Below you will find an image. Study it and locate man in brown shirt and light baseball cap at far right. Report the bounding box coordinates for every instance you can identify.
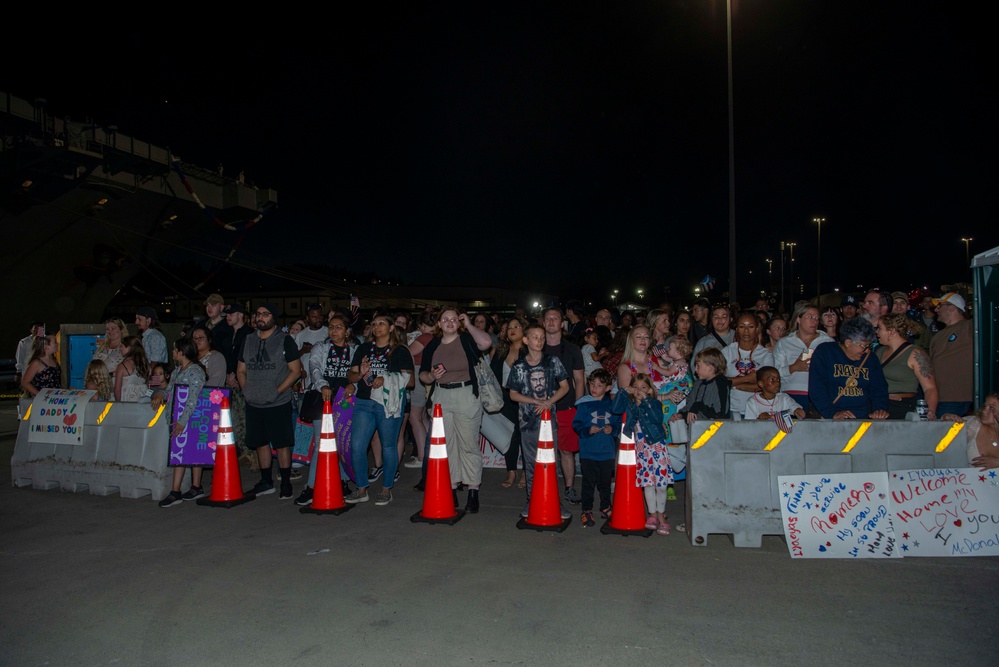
[930,292,975,417]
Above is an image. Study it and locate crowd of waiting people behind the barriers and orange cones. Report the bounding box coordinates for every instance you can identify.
[17,290,999,534]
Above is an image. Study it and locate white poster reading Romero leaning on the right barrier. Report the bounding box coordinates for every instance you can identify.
[777,472,902,558]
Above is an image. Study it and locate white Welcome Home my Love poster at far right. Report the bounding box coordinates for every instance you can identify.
[889,468,999,558]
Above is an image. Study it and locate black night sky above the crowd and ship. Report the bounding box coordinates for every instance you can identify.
[0,0,999,301]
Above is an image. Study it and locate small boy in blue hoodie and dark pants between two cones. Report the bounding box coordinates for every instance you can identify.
[572,368,621,528]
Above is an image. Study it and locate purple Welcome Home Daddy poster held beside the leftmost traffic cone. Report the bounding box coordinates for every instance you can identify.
[167,385,232,466]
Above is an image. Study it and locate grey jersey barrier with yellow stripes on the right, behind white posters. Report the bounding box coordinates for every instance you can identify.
[686,420,968,547]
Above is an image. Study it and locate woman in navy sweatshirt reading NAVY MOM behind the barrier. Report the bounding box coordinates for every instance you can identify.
[808,316,888,419]
